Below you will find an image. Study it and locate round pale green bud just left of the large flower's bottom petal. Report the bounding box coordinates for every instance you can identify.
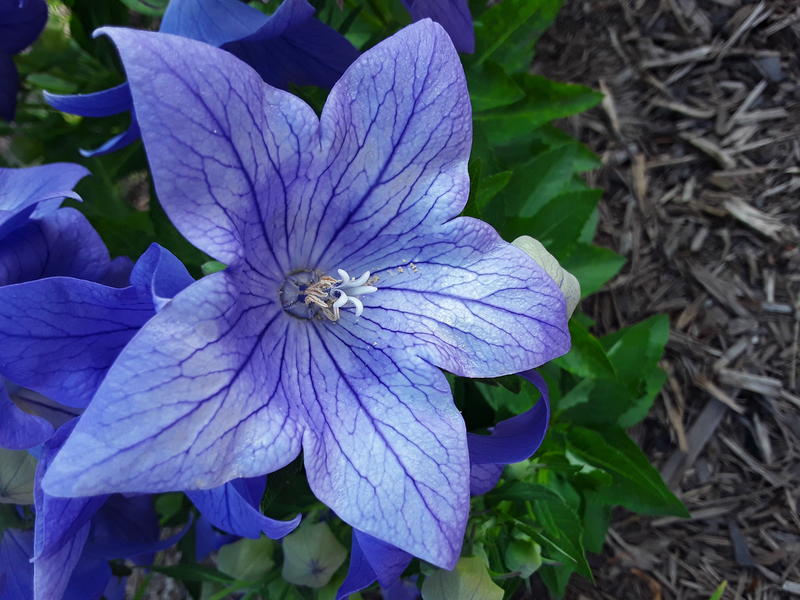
[282,523,347,588]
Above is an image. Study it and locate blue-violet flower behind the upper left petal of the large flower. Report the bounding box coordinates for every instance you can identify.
[45,0,358,156]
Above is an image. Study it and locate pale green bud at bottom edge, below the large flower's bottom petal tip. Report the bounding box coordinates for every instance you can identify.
[422,556,503,600]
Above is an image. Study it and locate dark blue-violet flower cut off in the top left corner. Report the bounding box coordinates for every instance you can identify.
[0,0,47,121]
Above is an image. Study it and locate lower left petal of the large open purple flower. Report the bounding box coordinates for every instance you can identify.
[44,269,300,496]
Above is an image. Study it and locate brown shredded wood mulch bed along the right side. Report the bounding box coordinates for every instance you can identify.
[535,0,800,600]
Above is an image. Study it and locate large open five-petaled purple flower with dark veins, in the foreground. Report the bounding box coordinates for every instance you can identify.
[44,20,569,567]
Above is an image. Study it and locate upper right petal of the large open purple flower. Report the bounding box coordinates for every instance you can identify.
[291,20,472,272]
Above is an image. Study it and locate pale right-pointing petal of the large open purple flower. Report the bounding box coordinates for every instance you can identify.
[353,217,569,377]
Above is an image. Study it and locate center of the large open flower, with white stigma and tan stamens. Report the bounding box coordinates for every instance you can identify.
[280,269,378,321]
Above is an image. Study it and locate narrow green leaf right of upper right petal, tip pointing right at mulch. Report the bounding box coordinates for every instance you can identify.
[473,75,602,144]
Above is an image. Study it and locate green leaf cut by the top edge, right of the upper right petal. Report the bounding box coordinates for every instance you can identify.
[475,0,561,72]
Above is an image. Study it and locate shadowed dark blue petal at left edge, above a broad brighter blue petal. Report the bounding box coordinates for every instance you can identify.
[0,208,110,286]
